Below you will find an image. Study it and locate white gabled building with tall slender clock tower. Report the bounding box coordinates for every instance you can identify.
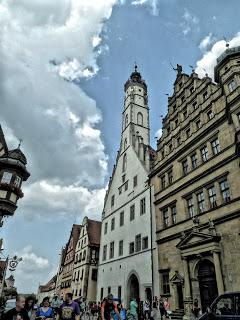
[97,66,159,305]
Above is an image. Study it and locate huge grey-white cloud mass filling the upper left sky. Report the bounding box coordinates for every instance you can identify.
[0,0,121,222]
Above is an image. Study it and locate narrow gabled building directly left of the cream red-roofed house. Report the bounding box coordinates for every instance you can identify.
[57,224,81,297]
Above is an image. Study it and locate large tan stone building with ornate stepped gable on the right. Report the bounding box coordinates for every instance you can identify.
[150,47,240,317]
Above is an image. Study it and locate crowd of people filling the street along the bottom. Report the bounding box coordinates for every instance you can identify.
[3,293,201,320]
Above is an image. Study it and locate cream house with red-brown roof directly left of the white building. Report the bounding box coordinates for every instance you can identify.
[72,217,101,301]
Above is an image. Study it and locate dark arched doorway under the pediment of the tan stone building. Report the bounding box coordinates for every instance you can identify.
[198,260,218,312]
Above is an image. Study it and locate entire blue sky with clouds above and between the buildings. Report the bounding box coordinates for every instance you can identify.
[0,0,240,293]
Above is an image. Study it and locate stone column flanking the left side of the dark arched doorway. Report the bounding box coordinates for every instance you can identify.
[182,257,192,320]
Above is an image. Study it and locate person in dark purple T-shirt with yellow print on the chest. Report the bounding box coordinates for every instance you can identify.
[56,292,80,320]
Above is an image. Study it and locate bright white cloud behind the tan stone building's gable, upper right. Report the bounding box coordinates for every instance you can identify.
[196,32,240,78]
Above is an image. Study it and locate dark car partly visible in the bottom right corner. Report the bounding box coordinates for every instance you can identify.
[199,291,240,320]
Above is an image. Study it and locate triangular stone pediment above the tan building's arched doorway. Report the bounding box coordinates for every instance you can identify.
[177,230,220,250]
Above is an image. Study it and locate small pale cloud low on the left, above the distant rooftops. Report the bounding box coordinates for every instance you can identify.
[14,245,57,293]
